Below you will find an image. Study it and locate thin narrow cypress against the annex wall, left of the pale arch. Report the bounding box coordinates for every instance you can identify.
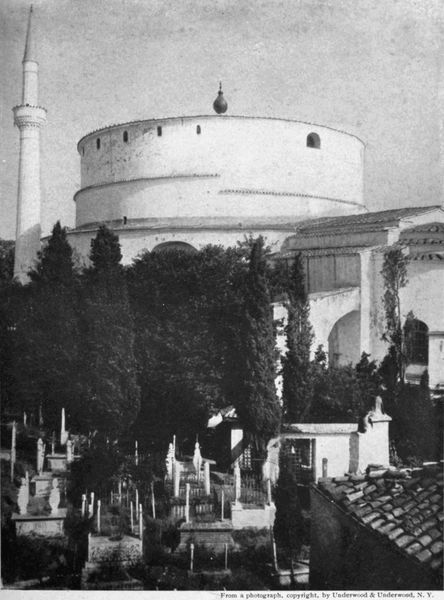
[282,254,313,421]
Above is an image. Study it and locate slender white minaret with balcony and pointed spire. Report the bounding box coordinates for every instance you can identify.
[12,5,46,283]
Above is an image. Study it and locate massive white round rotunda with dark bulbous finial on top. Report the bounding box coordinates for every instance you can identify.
[69,91,365,262]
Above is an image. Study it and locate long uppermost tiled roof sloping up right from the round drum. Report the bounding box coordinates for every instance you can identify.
[297,205,441,234]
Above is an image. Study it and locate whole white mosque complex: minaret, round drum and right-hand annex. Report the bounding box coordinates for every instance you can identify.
[14,11,444,393]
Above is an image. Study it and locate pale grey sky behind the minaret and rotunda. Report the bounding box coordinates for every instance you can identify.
[0,0,444,238]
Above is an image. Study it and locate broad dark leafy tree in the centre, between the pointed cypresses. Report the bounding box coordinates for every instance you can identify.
[128,246,245,449]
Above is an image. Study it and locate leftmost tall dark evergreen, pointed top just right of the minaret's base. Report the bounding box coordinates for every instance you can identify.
[10,222,80,429]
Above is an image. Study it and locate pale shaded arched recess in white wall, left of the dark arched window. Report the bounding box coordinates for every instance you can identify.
[328,310,361,367]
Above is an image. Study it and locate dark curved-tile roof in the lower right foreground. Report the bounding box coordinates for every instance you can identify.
[318,463,444,573]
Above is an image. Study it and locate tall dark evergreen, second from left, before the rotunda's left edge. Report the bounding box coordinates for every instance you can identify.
[81,226,140,438]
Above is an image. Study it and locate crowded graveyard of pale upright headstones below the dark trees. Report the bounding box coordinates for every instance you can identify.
[2,409,298,590]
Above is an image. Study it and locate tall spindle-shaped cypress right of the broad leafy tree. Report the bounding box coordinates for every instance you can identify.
[235,237,281,453]
